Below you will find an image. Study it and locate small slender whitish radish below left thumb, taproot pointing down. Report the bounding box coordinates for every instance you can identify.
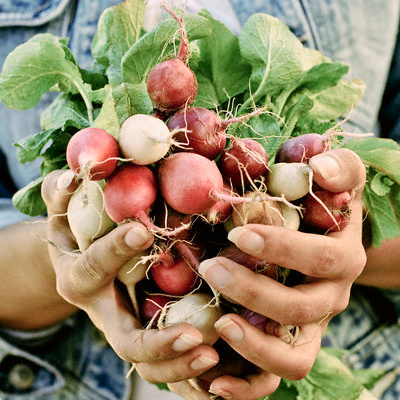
[117,253,148,317]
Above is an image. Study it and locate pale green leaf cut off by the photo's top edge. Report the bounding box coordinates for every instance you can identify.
[92,0,146,85]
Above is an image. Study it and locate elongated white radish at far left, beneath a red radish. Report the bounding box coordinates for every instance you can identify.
[67,180,115,252]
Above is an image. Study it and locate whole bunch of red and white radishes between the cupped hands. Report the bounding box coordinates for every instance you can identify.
[62,2,350,390]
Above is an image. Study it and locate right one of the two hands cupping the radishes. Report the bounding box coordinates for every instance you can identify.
[171,149,366,400]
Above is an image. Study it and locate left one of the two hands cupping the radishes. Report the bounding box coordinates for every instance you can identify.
[42,171,218,382]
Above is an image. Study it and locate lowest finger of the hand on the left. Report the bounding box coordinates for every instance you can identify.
[136,345,219,383]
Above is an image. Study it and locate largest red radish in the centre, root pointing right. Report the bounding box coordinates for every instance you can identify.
[158,153,252,214]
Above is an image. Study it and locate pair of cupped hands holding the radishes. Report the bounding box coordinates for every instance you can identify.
[43,149,366,400]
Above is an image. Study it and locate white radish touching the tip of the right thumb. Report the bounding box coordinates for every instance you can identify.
[267,163,311,201]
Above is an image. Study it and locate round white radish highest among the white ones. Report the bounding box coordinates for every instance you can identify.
[118,114,172,165]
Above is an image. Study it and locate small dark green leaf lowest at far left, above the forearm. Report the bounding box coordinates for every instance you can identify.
[12,177,47,217]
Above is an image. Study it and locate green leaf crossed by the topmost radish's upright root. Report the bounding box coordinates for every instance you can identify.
[121,14,211,84]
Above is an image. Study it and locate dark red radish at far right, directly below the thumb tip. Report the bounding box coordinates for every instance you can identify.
[304,189,351,232]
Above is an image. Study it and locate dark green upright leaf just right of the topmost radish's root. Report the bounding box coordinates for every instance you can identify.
[194,11,251,108]
